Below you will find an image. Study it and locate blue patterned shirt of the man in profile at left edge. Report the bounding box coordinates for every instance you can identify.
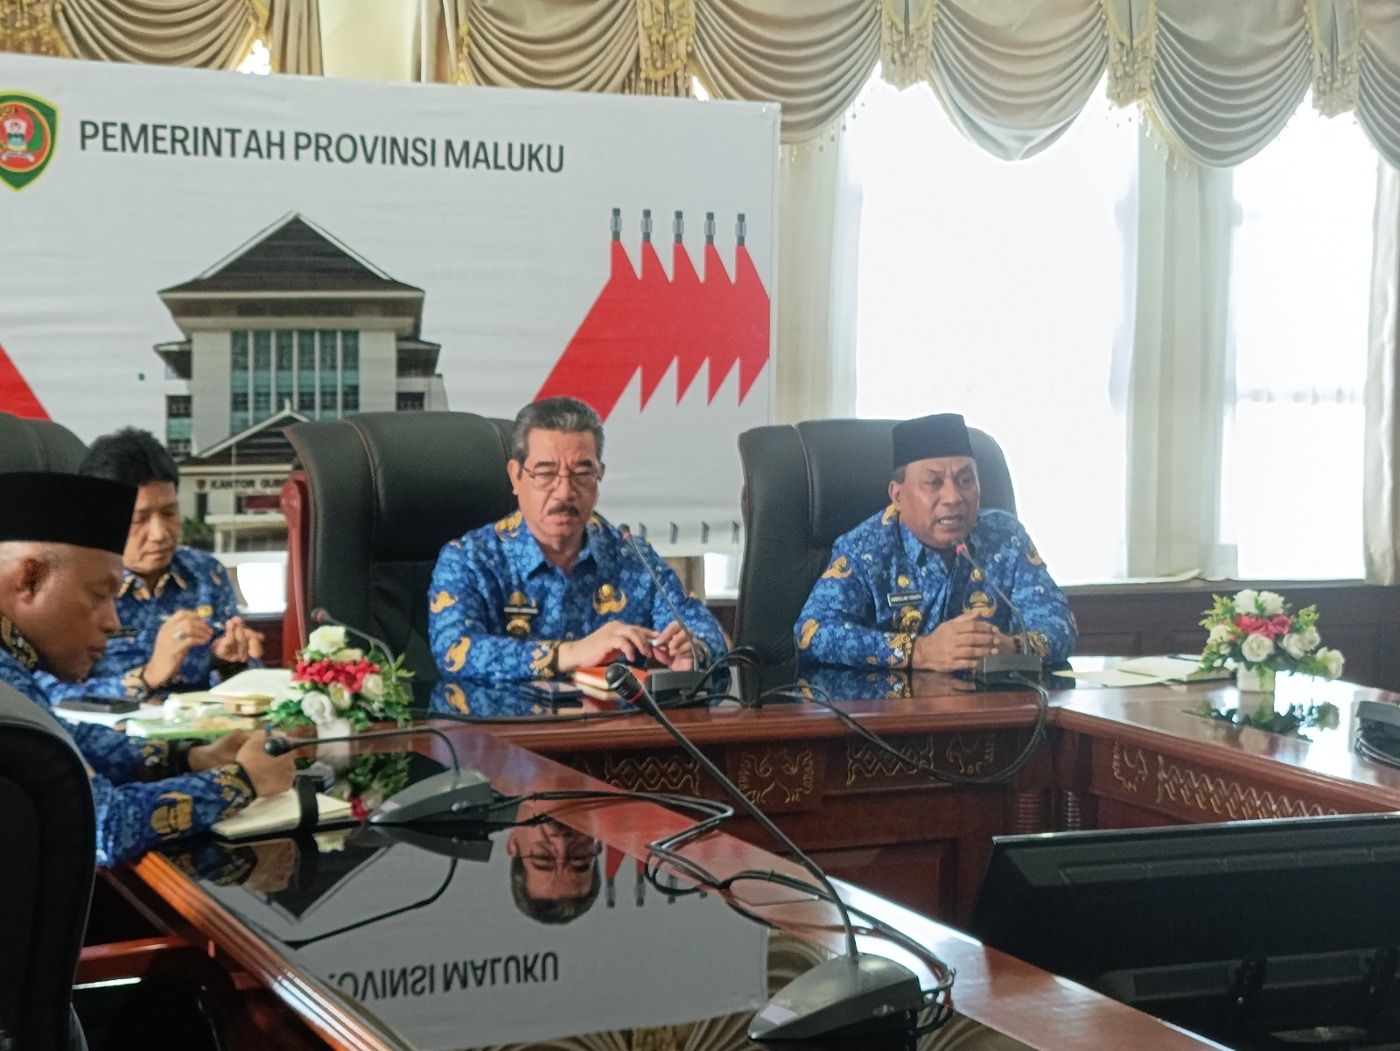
[0,616,256,865]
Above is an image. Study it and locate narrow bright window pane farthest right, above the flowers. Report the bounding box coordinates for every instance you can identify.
[1221,102,1378,579]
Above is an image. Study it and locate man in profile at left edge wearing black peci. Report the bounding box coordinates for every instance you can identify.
[0,472,294,865]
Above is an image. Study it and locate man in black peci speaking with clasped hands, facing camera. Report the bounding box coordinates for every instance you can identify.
[792,413,1078,672]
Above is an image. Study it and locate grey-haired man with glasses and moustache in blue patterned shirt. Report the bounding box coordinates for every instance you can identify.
[428,397,725,691]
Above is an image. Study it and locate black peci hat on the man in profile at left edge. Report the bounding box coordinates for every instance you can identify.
[0,470,136,554]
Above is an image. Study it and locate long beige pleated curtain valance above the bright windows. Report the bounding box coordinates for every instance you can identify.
[434,0,1400,167]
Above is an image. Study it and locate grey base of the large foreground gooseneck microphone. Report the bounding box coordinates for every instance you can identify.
[749,953,924,1041]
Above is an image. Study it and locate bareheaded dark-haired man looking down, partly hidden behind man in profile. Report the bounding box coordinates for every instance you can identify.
[41,427,262,703]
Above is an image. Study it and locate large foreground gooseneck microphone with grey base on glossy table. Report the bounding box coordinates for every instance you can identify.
[608,662,924,1040]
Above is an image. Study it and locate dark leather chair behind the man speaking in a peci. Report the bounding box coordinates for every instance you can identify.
[734,420,1016,665]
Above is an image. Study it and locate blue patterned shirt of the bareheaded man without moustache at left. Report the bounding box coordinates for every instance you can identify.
[39,547,258,704]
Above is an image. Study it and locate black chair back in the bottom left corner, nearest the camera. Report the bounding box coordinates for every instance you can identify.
[0,683,97,1051]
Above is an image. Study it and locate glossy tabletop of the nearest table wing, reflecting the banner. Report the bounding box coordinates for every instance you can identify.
[119,724,1226,1048]
